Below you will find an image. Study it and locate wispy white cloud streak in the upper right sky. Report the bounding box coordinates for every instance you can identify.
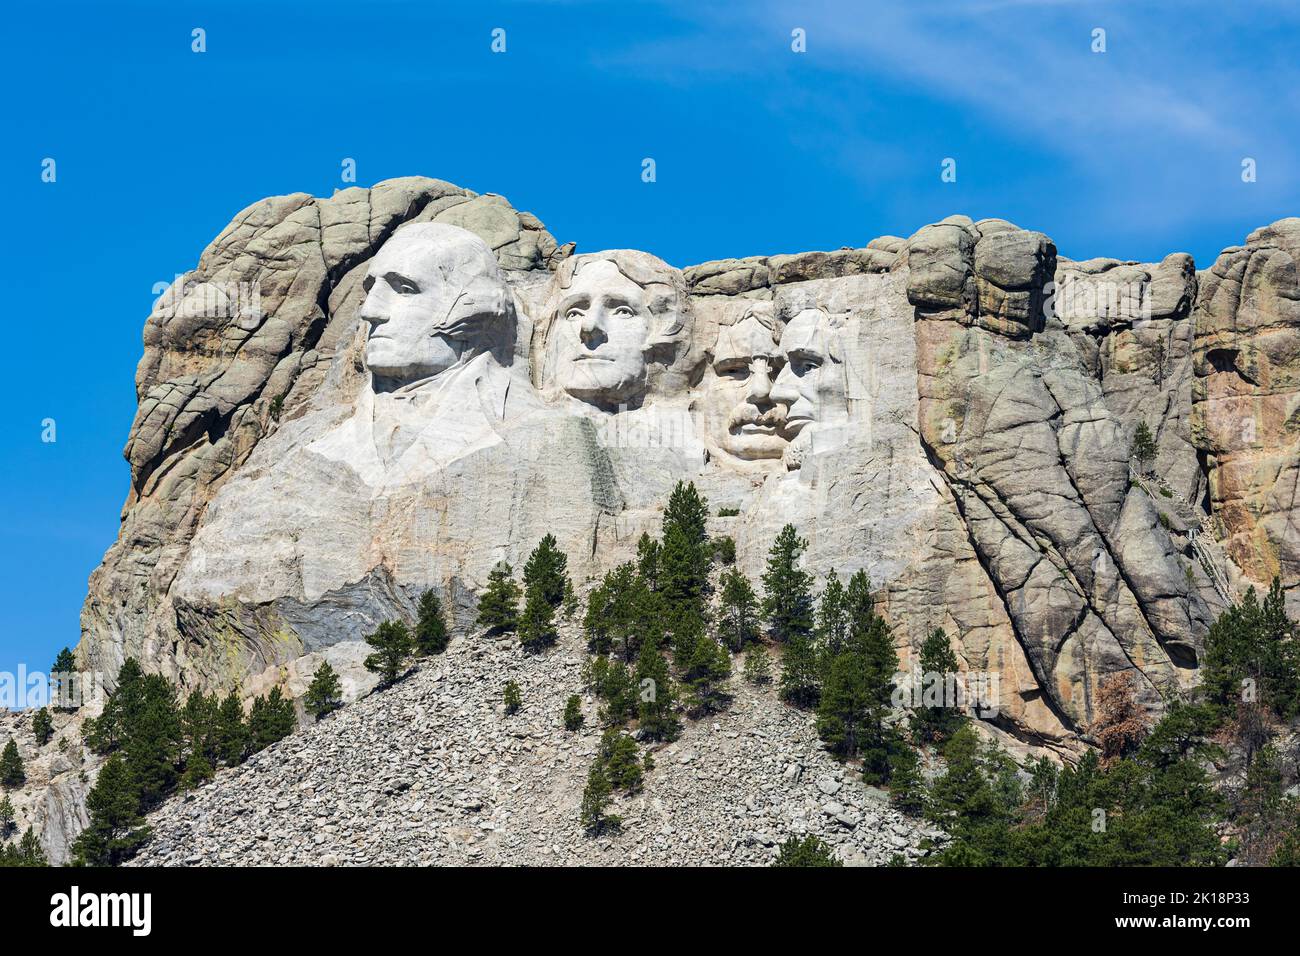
[605,0,1300,254]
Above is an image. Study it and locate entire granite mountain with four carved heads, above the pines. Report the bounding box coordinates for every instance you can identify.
[78,178,1300,744]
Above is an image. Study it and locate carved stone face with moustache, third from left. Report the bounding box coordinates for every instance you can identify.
[698,312,787,462]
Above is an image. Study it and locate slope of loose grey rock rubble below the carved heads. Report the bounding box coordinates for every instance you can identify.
[131,628,937,866]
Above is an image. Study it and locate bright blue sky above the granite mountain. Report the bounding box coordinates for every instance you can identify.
[0,0,1300,671]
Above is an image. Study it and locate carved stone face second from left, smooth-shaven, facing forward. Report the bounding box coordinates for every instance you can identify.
[556,260,654,403]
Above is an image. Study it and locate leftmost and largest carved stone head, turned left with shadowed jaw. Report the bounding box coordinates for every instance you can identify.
[359,222,514,390]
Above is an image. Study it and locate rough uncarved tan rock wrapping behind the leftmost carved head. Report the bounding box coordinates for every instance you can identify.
[79,178,566,684]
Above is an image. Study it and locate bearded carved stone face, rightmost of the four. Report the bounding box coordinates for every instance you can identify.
[772,308,848,467]
